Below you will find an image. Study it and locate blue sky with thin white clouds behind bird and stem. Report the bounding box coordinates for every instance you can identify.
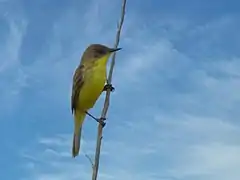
[0,0,240,180]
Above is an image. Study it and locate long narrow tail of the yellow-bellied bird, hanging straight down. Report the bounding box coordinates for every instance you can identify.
[72,111,86,157]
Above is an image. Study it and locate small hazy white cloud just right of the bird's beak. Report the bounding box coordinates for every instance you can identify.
[115,37,174,81]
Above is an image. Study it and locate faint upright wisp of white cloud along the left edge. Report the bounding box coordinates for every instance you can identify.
[0,16,28,114]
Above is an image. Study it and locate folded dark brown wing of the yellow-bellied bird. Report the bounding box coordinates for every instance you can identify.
[71,65,84,113]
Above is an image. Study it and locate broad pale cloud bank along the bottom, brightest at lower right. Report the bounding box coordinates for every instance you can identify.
[20,114,240,180]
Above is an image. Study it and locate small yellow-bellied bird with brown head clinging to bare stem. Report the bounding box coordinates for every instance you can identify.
[71,44,121,157]
